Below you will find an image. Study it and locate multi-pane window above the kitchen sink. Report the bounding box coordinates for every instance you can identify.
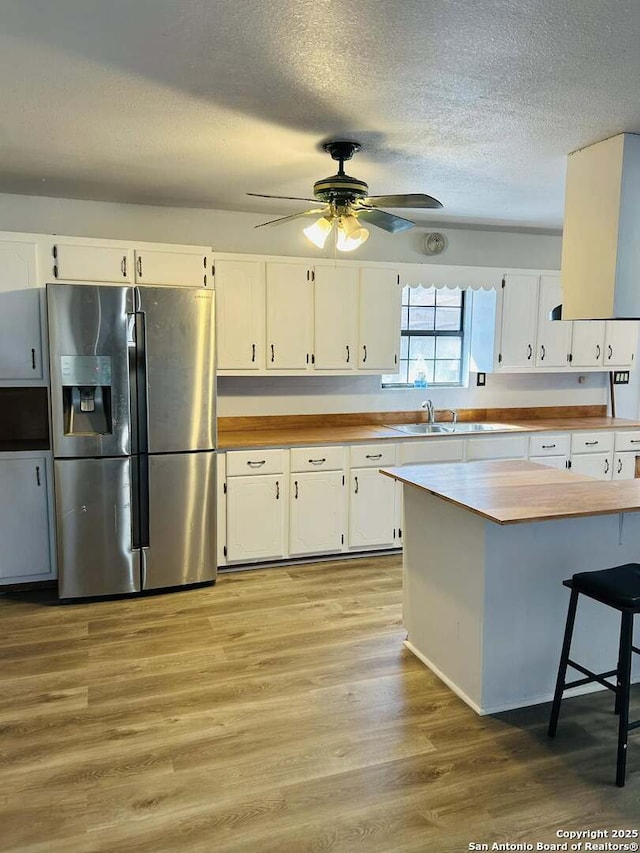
[382,286,464,388]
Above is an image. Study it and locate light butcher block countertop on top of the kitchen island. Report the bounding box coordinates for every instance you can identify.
[381,461,640,524]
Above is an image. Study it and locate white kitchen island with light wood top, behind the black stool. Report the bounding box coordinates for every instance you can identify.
[382,461,640,714]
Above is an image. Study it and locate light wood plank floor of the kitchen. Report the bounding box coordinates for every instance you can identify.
[0,557,640,853]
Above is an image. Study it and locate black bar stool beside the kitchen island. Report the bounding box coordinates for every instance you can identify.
[549,563,640,788]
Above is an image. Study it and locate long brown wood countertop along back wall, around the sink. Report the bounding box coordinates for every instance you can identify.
[218,406,640,450]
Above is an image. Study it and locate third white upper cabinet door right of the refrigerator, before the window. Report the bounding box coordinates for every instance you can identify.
[314,267,358,371]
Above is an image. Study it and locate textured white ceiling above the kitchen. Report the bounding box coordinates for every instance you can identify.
[0,0,640,228]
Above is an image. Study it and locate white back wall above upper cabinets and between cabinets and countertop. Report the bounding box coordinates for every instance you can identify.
[0,194,624,417]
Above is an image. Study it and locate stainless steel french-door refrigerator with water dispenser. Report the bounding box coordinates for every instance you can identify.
[47,284,216,598]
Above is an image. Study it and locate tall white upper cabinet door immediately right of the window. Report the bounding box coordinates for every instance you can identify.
[498,275,538,369]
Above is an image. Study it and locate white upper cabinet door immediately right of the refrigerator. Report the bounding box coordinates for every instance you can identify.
[215,260,265,370]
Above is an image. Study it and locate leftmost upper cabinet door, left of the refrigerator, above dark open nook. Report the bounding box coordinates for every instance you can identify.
[0,241,43,380]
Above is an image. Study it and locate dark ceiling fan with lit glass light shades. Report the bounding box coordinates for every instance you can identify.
[247,139,442,252]
